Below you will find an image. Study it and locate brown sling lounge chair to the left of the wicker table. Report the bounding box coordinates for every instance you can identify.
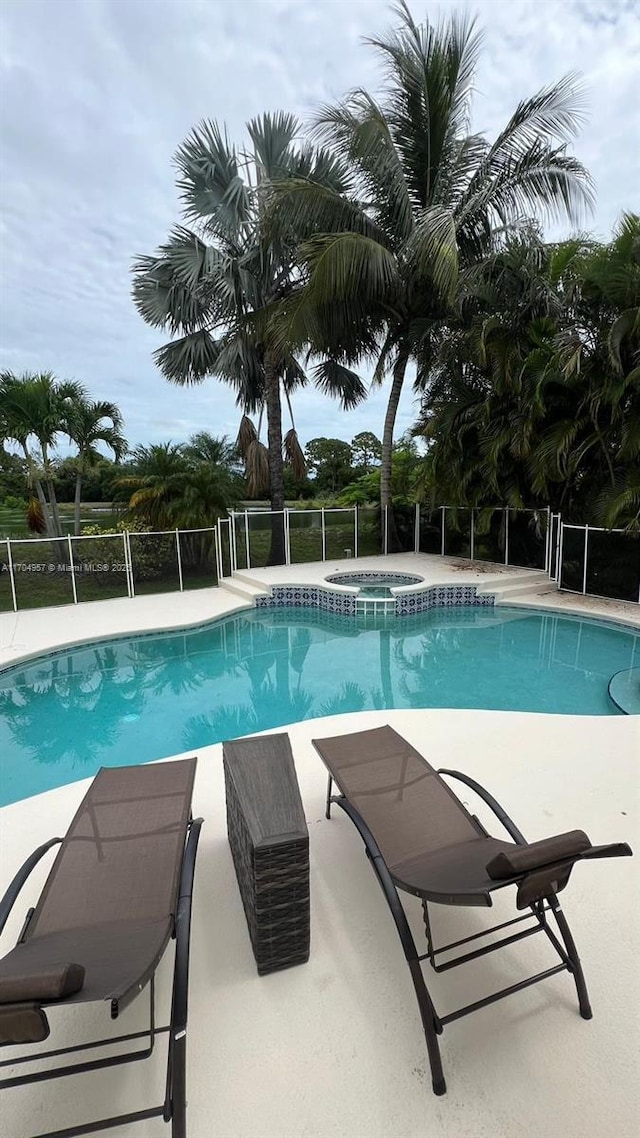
[0,759,202,1138]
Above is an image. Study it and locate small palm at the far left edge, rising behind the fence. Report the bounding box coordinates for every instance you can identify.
[0,371,88,537]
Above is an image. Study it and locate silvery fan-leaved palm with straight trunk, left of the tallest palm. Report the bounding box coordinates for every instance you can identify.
[133,114,364,563]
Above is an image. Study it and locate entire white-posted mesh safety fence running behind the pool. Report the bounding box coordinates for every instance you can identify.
[0,504,640,611]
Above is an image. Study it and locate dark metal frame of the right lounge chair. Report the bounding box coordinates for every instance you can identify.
[325,767,593,1095]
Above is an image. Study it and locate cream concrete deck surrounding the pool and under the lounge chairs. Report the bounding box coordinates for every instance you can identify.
[0,554,640,1138]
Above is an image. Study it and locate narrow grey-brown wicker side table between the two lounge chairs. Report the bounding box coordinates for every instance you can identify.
[222,734,310,975]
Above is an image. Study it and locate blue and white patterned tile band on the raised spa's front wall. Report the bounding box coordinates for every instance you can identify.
[255,585,495,617]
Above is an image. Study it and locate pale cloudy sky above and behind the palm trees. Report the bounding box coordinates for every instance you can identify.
[0,0,640,444]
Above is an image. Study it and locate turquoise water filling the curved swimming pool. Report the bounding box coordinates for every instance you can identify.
[0,607,640,805]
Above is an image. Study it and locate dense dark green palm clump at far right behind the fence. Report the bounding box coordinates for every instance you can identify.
[419,215,640,527]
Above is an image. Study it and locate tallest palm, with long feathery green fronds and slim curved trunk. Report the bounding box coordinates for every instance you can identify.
[266,0,592,546]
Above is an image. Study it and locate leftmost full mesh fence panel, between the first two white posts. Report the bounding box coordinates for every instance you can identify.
[11,537,73,609]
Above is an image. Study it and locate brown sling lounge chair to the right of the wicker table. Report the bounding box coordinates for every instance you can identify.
[313,727,631,1095]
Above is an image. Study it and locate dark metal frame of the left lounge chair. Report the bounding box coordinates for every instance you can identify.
[0,817,203,1138]
